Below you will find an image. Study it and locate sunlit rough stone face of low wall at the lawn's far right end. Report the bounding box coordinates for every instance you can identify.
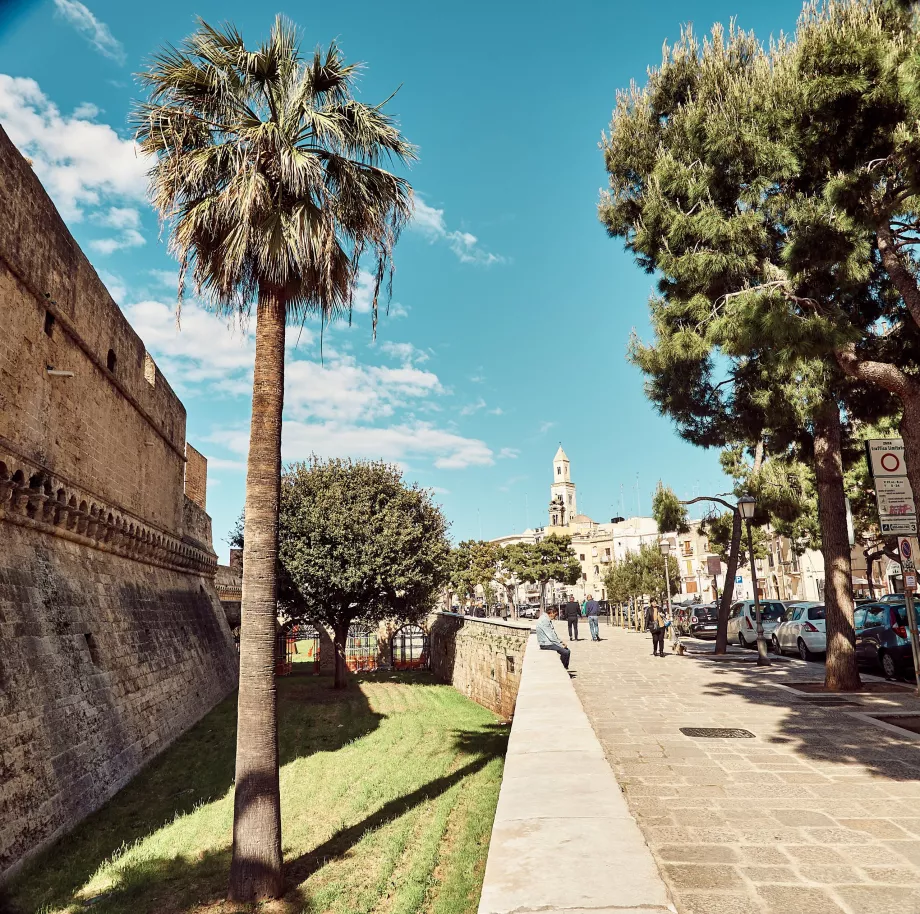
[428,613,531,718]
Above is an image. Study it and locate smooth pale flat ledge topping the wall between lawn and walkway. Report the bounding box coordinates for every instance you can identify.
[479,637,675,914]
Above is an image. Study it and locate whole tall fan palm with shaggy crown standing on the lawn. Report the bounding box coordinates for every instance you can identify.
[132,17,415,901]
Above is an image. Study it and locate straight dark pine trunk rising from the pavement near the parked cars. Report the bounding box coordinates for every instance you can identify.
[815,399,862,692]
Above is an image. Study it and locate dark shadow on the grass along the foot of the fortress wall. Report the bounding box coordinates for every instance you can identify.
[7,676,382,914]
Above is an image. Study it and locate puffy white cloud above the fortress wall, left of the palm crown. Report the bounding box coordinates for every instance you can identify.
[0,73,149,222]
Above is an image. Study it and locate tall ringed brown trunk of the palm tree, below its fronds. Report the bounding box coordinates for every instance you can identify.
[228,289,286,902]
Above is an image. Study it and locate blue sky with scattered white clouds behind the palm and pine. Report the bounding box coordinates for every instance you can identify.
[0,0,800,557]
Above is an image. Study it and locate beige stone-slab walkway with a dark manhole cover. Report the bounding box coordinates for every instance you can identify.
[563,624,920,914]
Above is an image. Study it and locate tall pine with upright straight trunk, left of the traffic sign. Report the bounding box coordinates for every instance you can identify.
[601,21,887,689]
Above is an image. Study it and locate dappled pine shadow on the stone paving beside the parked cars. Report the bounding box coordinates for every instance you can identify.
[682,655,920,782]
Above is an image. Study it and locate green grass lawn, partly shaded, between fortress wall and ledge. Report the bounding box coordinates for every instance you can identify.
[7,673,508,914]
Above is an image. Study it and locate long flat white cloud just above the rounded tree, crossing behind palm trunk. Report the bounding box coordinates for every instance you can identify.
[210,421,495,470]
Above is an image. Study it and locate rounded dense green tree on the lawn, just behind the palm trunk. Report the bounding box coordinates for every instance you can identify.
[280,459,450,689]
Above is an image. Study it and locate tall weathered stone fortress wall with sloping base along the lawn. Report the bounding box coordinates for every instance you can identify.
[0,128,237,879]
